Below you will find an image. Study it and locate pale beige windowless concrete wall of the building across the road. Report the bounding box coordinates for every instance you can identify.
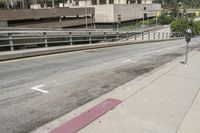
[93,4,161,23]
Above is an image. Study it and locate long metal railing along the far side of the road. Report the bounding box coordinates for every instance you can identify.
[0,30,184,51]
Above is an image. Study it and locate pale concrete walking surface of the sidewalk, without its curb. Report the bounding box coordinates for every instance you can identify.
[80,51,200,133]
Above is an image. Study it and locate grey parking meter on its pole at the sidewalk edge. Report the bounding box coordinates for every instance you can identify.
[185,29,192,66]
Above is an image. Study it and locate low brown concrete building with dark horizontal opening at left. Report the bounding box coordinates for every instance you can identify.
[0,7,95,28]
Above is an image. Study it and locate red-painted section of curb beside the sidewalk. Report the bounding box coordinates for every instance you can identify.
[49,99,122,133]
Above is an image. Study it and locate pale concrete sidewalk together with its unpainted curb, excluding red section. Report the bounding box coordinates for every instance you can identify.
[33,50,200,133]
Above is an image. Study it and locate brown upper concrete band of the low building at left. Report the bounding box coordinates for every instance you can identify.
[0,8,95,21]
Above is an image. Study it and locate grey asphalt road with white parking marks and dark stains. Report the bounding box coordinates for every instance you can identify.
[0,38,200,133]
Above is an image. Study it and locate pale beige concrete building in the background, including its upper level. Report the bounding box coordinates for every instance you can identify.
[79,0,161,27]
